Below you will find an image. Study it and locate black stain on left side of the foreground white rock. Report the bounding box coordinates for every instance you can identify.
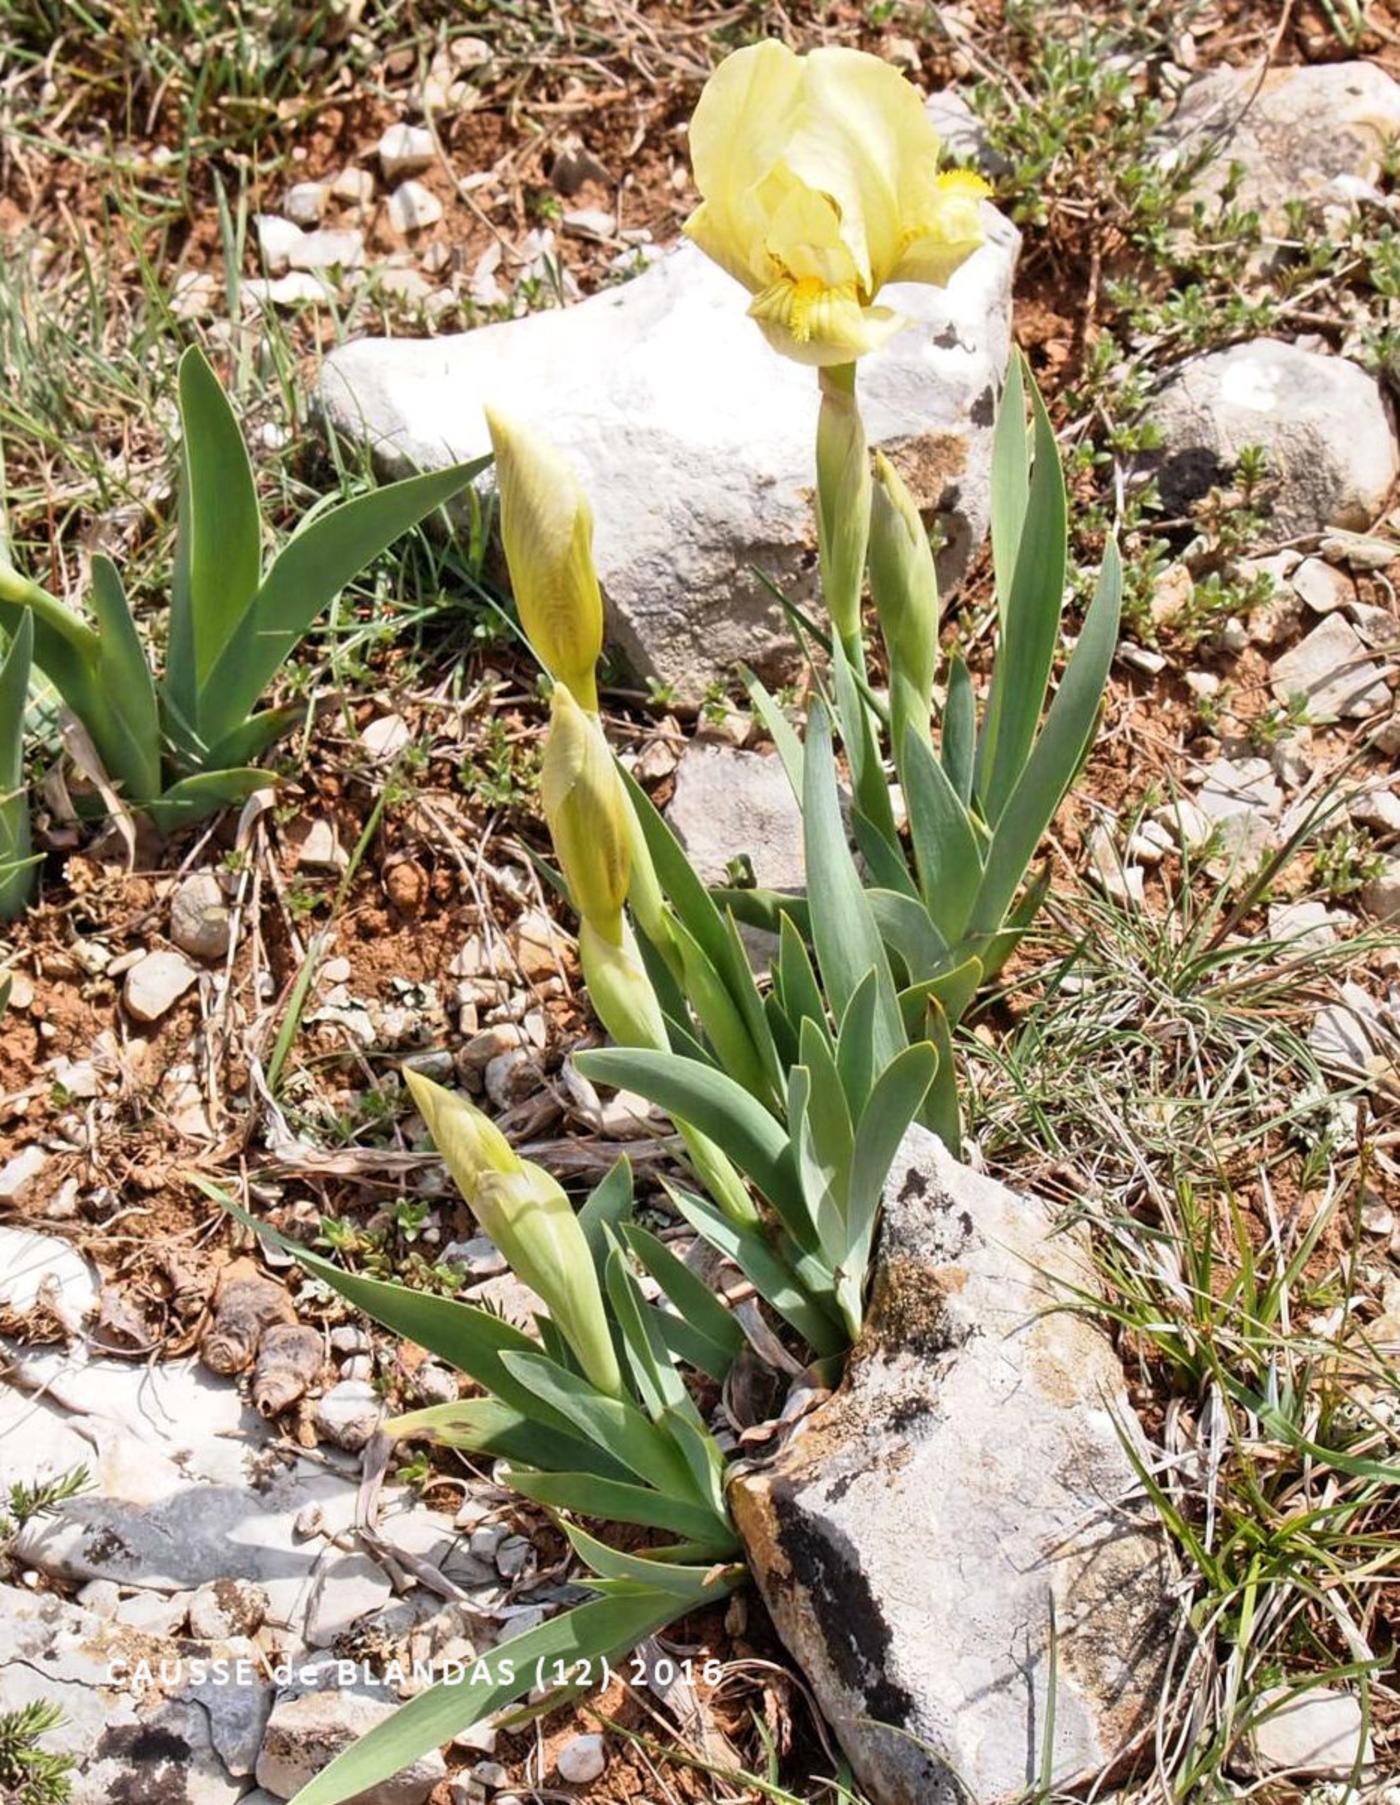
[772,1480,915,1729]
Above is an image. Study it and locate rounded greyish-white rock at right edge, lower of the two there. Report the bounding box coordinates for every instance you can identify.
[1142,338,1400,538]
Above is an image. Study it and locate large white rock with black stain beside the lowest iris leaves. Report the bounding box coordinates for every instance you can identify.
[731,1128,1171,1805]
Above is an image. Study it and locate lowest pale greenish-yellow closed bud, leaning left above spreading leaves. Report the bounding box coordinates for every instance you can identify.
[404,1070,622,1397]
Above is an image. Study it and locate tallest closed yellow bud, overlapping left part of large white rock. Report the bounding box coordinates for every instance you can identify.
[485,408,603,713]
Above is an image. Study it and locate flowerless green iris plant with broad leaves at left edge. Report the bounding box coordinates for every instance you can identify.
[0,347,485,832]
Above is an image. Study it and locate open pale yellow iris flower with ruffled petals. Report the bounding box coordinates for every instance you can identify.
[686,38,989,365]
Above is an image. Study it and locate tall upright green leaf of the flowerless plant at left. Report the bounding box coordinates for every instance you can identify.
[169,345,262,718]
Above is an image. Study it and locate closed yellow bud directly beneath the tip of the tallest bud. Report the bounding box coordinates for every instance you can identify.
[539,684,631,944]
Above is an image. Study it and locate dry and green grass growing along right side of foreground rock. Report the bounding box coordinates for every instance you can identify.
[971,859,1400,1801]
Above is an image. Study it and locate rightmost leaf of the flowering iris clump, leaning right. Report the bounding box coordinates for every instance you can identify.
[971,542,1122,933]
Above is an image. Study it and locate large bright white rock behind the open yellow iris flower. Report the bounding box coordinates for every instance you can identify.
[321,208,1019,697]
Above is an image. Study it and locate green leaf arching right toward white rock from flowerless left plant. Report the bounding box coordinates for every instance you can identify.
[197,458,489,742]
